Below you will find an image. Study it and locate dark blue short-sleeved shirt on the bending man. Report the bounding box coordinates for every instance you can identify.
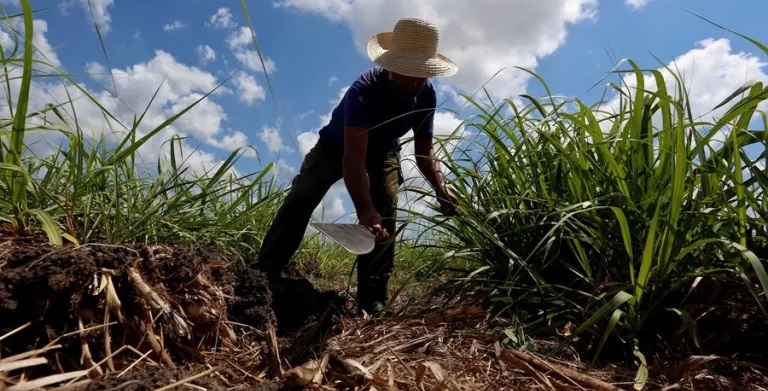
[320,66,437,152]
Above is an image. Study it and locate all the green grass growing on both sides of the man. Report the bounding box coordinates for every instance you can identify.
[0,0,768,384]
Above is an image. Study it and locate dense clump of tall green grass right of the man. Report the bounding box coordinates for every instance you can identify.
[404,24,768,384]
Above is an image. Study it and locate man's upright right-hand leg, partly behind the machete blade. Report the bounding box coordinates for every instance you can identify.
[357,155,401,314]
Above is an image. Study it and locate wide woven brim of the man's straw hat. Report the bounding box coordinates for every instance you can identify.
[367,32,459,78]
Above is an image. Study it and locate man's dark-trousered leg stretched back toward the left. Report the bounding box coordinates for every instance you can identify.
[256,143,343,278]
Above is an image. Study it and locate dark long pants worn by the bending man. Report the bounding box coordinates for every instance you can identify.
[256,143,403,310]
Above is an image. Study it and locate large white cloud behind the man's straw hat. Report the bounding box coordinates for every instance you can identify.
[275,0,598,98]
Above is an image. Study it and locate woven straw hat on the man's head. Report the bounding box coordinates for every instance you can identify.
[368,18,459,78]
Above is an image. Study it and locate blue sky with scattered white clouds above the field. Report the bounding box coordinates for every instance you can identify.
[0,0,768,225]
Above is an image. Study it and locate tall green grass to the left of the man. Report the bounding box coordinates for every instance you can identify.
[0,1,283,258]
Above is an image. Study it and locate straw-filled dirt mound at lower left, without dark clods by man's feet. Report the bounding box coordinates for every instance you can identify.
[0,242,240,367]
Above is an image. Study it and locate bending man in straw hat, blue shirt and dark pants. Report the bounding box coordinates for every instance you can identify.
[256,18,458,315]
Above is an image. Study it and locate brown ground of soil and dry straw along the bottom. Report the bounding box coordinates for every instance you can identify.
[0,228,768,390]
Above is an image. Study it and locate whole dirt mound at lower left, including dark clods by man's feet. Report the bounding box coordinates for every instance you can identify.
[0,233,346,389]
